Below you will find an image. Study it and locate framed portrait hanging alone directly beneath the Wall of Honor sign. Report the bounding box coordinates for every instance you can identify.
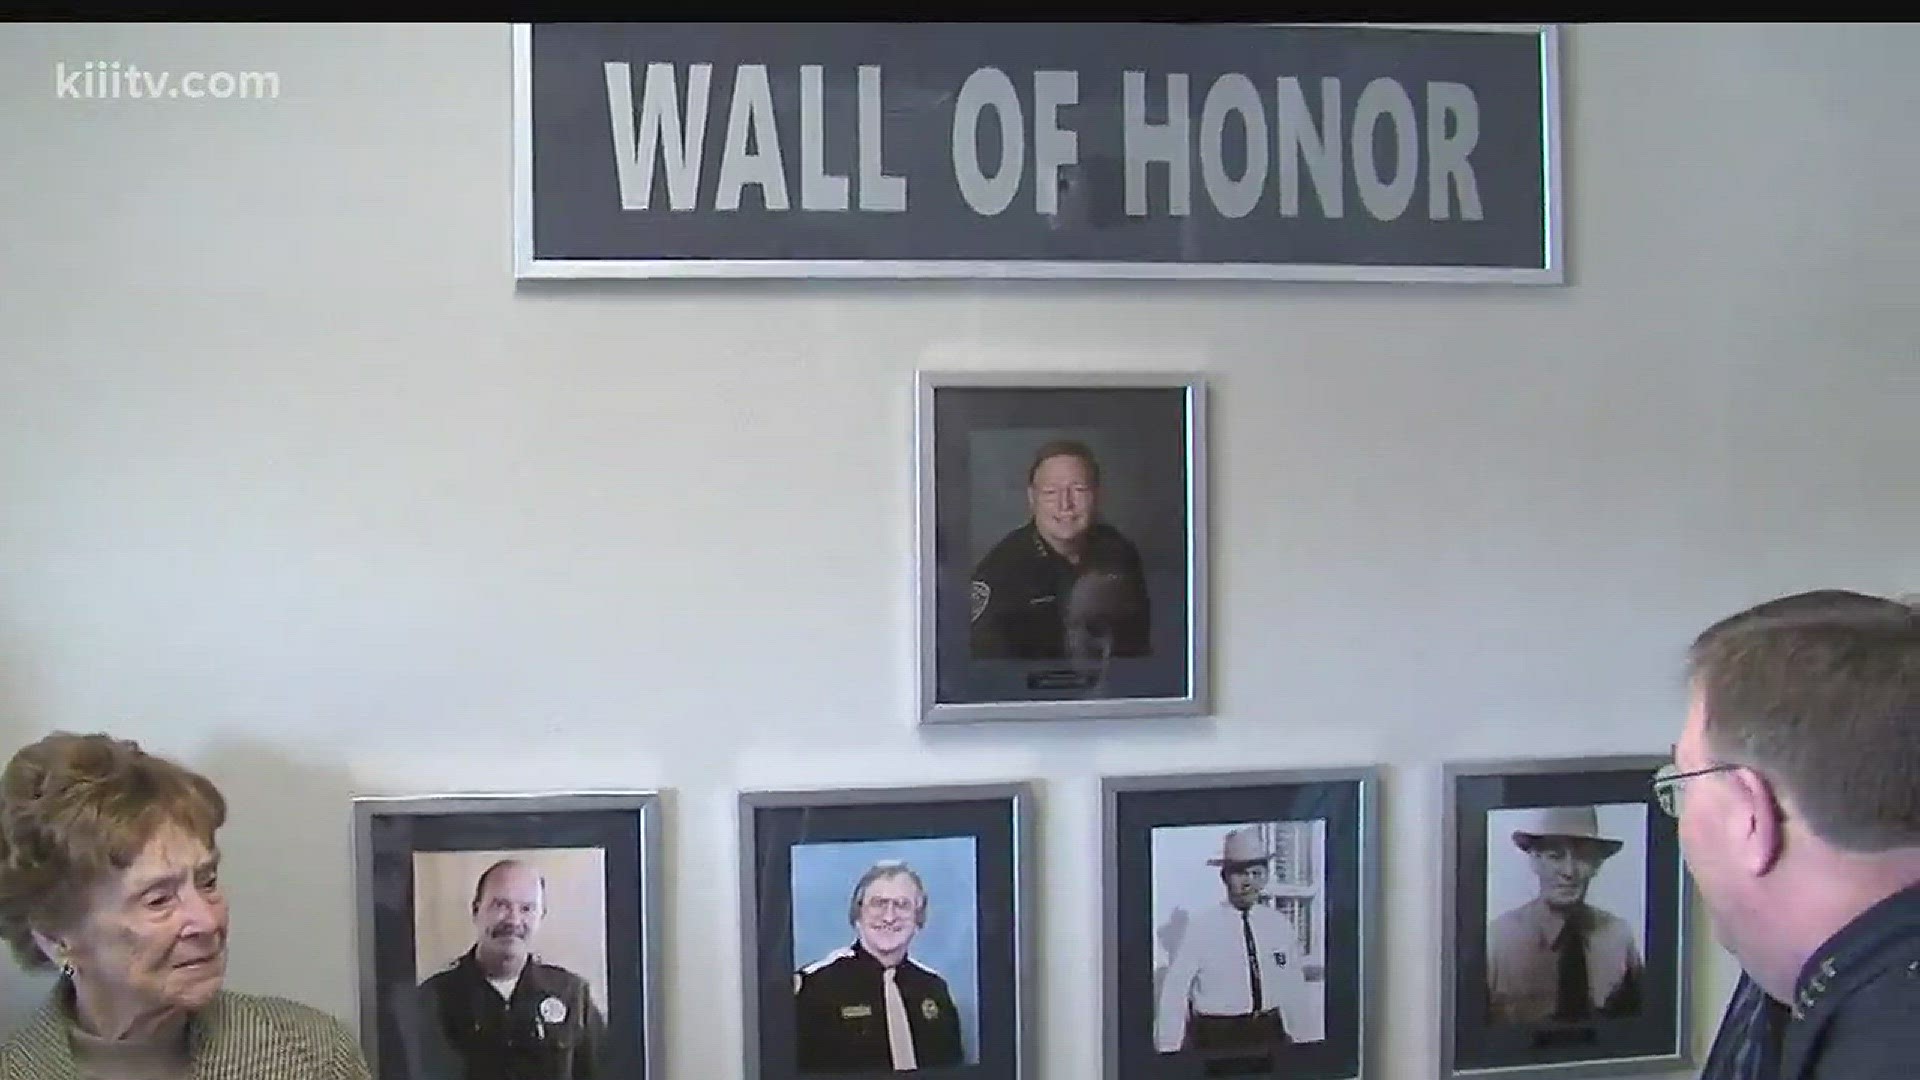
[914,373,1210,723]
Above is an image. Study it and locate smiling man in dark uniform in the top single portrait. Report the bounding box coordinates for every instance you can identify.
[968,440,1150,661]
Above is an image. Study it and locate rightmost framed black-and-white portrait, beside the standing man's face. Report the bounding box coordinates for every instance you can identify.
[1440,755,1693,1078]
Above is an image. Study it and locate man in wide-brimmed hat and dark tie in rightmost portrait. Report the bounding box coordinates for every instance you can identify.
[1486,805,1644,1024]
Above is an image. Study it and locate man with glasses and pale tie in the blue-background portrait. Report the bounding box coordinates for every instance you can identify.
[793,863,966,1072]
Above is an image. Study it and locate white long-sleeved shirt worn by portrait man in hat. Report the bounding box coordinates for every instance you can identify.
[1154,901,1308,1053]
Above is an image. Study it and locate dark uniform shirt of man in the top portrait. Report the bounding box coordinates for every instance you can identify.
[968,521,1150,659]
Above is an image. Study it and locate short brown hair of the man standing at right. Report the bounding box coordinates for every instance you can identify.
[1688,590,1920,851]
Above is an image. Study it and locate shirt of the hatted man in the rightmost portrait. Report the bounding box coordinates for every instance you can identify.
[1486,897,1642,1024]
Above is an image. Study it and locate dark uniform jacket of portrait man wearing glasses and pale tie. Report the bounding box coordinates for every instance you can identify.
[793,942,966,1072]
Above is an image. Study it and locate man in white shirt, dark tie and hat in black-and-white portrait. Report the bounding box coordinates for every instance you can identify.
[1154,824,1325,1053]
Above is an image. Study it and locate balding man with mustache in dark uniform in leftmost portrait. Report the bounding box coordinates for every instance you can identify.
[413,859,607,1080]
